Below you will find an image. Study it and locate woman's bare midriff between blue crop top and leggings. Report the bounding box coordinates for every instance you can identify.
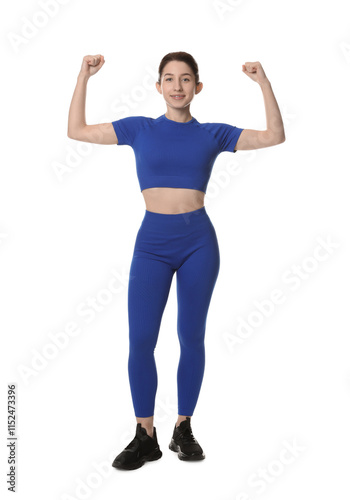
[142,188,205,214]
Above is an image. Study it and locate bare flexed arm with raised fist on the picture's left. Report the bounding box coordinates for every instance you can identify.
[67,54,118,144]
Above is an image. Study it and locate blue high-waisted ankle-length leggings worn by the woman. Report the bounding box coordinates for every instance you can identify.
[128,207,220,417]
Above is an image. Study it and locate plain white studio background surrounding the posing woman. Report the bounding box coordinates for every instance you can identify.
[0,0,350,500]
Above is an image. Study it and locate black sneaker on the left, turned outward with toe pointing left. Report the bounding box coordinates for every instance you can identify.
[112,423,162,470]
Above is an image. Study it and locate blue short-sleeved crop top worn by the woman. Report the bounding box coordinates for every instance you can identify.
[112,114,244,193]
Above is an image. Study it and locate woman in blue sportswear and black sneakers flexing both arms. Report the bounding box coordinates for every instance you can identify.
[68,52,285,470]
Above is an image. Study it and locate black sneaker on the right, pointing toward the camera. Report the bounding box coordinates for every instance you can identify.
[169,417,205,460]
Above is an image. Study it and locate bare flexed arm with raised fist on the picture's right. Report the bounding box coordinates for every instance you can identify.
[235,62,286,150]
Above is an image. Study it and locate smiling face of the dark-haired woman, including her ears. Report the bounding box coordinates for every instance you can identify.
[156,61,203,109]
